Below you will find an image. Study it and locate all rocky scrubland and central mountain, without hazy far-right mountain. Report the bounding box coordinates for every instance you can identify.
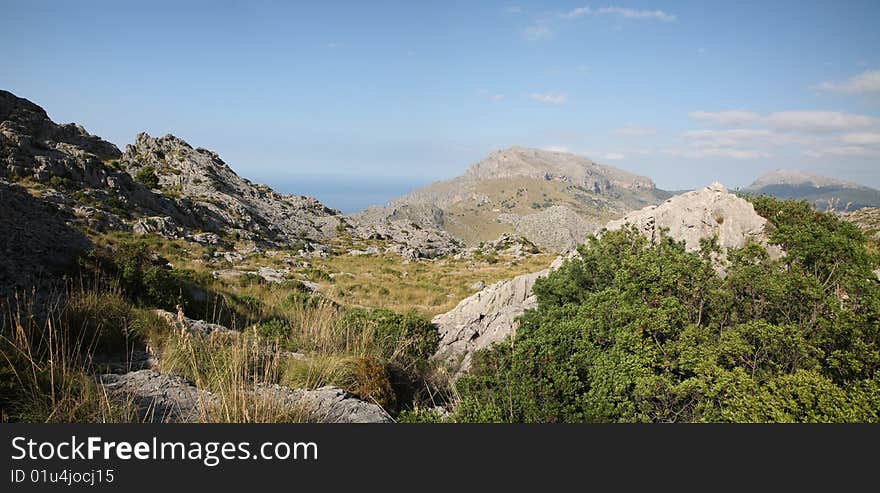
[0,92,880,423]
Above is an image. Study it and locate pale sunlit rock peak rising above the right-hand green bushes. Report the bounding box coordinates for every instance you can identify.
[605,183,782,257]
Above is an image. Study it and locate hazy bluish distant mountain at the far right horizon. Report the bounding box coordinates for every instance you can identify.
[744,169,880,211]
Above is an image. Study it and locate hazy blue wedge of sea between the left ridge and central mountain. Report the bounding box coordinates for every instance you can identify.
[270,177,433,214]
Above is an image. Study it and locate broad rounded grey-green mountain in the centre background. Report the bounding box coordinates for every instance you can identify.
[351,147,668,252]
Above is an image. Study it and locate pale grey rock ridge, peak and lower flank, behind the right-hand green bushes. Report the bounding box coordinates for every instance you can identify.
[432,183,781,378]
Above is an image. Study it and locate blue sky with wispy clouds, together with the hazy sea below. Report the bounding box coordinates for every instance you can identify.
[0,0,880,210]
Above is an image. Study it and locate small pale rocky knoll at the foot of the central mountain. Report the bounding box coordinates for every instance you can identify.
[498,205,599,253]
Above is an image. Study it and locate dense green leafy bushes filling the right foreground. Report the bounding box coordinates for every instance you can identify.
[456,197,880,422]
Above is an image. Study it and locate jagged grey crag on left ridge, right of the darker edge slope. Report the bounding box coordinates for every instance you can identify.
[120,133,341,245]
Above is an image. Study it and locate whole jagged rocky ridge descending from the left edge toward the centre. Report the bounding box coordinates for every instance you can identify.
[0,91,343,258]
